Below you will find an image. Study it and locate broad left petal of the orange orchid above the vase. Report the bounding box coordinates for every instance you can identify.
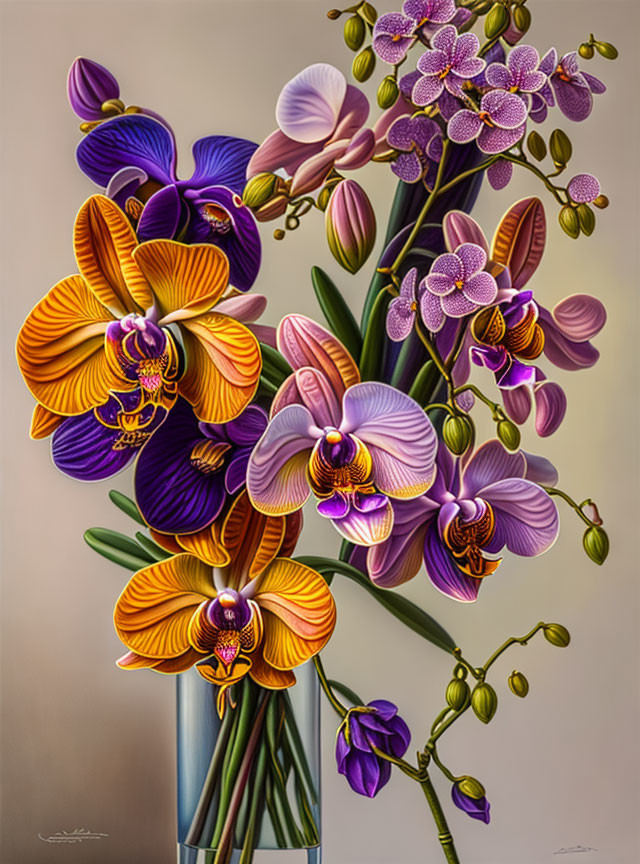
[114,554,216,660]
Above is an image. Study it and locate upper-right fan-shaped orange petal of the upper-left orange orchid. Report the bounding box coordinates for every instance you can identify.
[133,240,229,326]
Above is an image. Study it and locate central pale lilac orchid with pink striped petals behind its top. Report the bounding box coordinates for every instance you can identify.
[247,315,436,546]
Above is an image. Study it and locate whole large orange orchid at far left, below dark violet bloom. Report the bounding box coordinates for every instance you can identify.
[17,195,261,426]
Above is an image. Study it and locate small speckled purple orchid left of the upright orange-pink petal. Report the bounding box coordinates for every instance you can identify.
[420,243,498,333]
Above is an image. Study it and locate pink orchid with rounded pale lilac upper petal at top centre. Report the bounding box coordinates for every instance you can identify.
[247,63,376,196]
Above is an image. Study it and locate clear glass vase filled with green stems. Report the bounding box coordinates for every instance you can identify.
[177,663,321,864]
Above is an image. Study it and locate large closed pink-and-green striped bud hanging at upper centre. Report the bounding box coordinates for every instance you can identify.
[325,180,376,273]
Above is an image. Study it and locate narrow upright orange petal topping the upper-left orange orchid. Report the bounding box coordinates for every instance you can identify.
[73,195,153,318]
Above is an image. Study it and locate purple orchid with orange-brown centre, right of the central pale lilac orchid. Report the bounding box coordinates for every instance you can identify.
[367,439,559,603]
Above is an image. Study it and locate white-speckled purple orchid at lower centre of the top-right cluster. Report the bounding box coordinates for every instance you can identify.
[447,90,527,154]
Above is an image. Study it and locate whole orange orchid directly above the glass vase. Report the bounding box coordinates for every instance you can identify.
[114,493,336,715]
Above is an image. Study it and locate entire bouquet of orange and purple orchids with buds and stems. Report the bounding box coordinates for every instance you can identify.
[17,0,617,864]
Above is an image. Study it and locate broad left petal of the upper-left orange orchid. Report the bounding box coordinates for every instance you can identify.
[16,276,125,415]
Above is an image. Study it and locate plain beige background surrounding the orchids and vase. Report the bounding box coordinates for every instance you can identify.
[0,0,640,864]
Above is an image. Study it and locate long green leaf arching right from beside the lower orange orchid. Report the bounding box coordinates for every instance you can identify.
[296,555,456,653]
